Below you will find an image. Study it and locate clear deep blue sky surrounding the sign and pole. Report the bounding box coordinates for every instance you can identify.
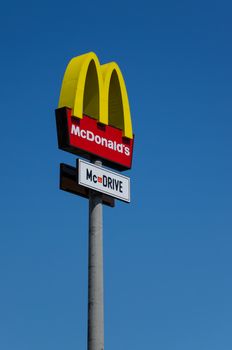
[0,0,232,350]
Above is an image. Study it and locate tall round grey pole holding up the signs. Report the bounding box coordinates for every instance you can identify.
[88,160,104,350]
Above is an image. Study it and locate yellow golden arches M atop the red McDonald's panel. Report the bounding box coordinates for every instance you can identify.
[58,52,133,139]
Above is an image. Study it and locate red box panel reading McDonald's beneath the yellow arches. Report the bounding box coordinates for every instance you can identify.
[56,108,133,170]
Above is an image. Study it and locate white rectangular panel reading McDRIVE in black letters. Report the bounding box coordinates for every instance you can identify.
[78,159,130,202]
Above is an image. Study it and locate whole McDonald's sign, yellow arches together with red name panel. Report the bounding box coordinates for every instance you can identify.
[56,52,134,170]
